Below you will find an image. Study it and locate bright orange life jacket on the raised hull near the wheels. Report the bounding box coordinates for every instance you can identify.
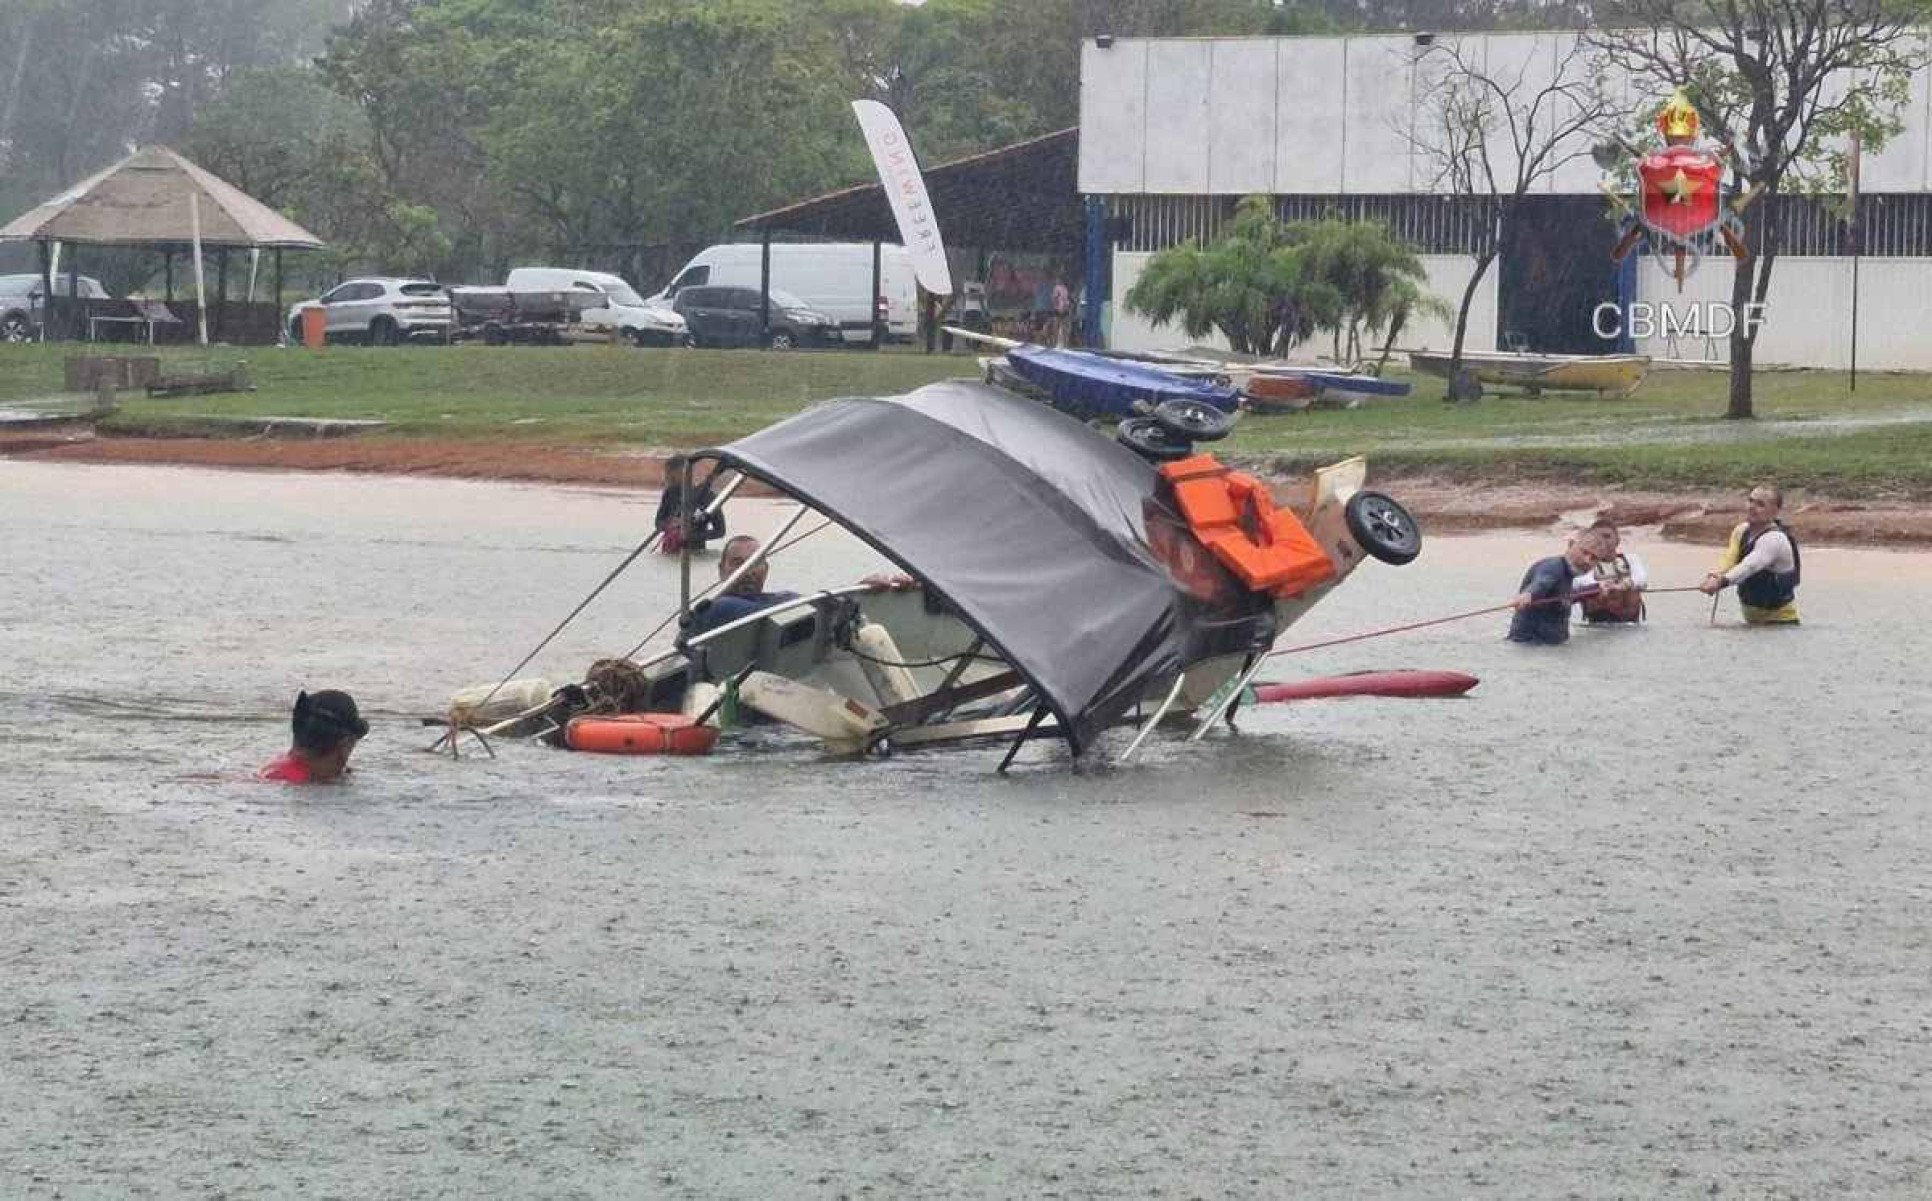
[1161,454,1335,599]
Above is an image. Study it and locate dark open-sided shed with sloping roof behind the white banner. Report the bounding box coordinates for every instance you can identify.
[734,129,1105,340]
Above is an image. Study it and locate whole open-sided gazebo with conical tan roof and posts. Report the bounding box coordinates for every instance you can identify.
[0,147,323,342]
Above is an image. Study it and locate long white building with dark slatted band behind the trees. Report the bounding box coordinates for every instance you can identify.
[1080,33,1932,369]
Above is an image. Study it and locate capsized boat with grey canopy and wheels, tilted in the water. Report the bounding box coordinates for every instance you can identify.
[467,380,1420,767]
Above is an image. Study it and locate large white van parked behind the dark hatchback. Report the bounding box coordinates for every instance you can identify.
[651,241,920,342]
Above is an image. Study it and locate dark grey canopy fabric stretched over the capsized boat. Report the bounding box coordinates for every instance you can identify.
[703,380,1273,753]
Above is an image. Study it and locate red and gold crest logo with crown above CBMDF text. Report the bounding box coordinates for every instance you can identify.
[1598,91,1756,292]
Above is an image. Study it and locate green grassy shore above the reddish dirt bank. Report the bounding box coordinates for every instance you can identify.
[0,346,1932,498]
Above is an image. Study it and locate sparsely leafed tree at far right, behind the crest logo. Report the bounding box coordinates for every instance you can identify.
[1588,0,1932,417]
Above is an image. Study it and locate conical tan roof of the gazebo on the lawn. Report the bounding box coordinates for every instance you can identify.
[0,147,323,251]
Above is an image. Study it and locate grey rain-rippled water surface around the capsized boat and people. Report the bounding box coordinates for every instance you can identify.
[0,461,1932,1197]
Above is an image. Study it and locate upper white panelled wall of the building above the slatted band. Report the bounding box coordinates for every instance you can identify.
[1080,33,1932,195]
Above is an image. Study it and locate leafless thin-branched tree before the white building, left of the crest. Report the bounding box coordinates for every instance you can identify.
[1405,32,1613,400]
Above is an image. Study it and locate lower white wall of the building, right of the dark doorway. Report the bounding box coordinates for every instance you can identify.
[1636,257,1932,371]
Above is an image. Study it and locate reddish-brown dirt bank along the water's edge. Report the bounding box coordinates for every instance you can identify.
[15,431,1932,546]
